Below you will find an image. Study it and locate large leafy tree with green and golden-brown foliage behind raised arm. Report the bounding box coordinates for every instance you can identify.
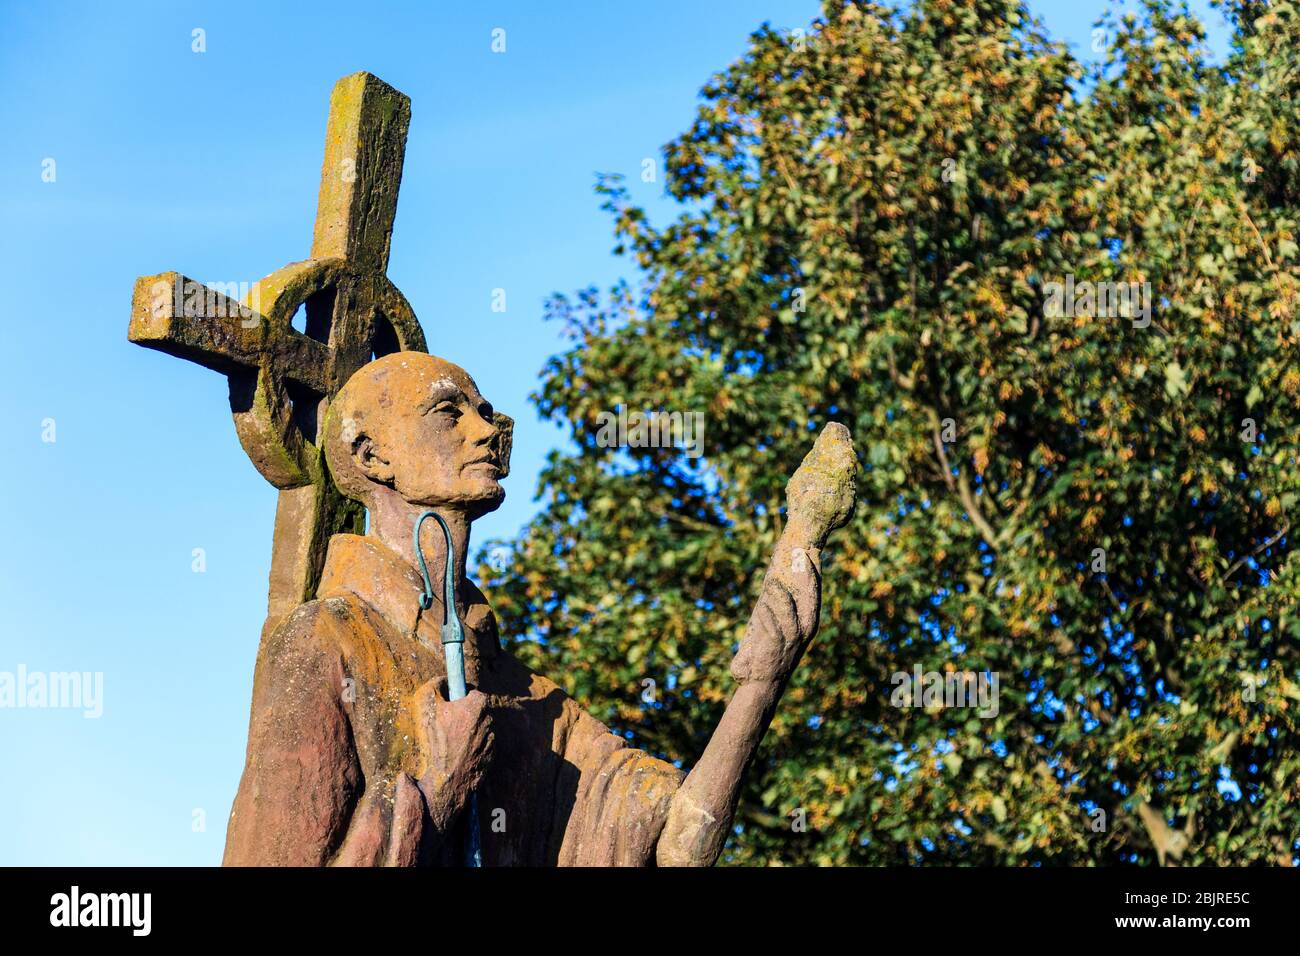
[481,0,1300,865]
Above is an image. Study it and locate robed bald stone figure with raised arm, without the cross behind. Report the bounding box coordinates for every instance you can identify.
[226,352,855,866]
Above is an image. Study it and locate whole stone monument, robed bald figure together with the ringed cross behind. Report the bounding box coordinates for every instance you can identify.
[129,73,857,866]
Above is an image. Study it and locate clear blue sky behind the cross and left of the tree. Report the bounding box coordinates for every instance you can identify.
[0,0,1223,865]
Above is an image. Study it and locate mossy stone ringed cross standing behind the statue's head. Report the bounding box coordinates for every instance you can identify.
[127,73,425,637]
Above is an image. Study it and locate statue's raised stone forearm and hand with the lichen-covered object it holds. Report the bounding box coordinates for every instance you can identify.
[655,423,857,866]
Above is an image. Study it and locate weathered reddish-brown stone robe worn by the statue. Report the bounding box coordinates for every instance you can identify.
[225,535,684,866]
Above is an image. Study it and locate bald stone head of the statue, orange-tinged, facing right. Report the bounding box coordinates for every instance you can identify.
[324,352,511,516]
